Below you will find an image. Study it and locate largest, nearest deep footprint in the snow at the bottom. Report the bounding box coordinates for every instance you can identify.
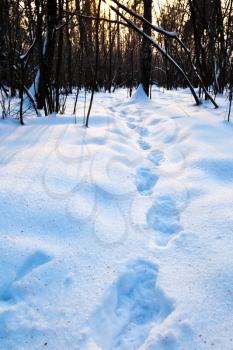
[88,260,174,350]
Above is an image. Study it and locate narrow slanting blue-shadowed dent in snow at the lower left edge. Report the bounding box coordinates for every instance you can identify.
[0,251,51,303]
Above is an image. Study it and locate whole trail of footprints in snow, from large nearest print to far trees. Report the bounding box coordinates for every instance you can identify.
[81,106,185,350]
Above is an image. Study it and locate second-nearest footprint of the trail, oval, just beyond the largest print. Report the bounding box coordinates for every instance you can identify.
[147,195,182,246]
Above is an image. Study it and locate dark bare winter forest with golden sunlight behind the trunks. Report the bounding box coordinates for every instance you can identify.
[0,0,233,125]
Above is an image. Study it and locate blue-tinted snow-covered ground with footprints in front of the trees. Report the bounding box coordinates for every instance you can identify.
[0,89,233,350]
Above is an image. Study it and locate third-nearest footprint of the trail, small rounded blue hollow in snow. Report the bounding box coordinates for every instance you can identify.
[136,168,159,195]
